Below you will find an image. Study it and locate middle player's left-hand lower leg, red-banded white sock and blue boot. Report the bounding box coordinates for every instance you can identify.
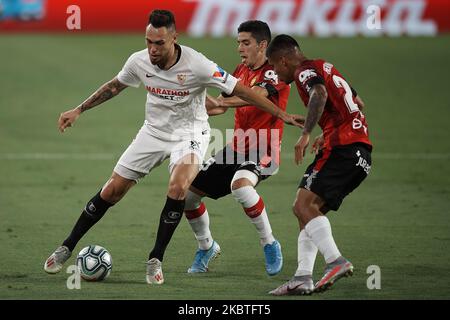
[184,185,221,273]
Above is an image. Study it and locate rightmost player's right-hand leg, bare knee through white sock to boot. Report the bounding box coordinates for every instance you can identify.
[294,188,353,292]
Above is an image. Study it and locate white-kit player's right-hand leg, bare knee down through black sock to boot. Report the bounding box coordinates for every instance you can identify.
[146,153,200,284]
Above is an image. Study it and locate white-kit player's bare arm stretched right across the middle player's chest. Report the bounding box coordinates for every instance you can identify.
[232,82,303,127]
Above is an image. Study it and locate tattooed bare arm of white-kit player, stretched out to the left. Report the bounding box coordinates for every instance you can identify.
[58,78,128,132]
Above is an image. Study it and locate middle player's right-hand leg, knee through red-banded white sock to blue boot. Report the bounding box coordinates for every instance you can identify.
[231,174,283,276]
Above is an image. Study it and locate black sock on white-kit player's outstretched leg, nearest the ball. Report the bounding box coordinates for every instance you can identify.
[63,191,112,251]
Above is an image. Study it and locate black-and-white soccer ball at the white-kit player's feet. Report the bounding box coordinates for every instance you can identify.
[77,245,112,281]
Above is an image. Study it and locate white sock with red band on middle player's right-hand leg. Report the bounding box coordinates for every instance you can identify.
[232,186,275,246]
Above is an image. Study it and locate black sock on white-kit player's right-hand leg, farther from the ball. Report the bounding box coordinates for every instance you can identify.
[148,197,184,261]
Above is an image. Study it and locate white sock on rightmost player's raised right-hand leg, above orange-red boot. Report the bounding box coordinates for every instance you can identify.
[305,216,341,263]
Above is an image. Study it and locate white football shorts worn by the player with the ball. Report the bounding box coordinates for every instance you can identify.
[114,124,210,182]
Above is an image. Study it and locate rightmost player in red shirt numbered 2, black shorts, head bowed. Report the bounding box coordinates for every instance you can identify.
[267,35,372,295]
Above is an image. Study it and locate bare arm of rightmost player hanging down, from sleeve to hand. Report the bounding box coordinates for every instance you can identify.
[295,84,328,164]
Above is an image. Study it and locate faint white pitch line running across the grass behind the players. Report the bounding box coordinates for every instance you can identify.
[0,152,450,160]
